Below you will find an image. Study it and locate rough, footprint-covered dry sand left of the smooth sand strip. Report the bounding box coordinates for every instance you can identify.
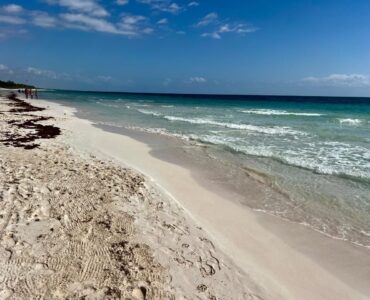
[0,98,262,299]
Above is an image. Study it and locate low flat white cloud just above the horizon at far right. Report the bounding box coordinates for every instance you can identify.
[303,74,370,87]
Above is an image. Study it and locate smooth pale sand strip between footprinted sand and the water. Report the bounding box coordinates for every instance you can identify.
[26,95,370,299]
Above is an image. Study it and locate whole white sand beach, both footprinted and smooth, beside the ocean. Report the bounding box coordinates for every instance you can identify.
[0,92,370,300]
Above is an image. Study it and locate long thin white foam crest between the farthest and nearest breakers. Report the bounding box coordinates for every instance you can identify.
[164,116,306,135]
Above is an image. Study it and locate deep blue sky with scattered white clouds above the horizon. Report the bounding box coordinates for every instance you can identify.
[0,0,370,97]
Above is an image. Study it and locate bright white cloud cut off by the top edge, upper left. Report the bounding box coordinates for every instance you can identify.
[45,0,109,17]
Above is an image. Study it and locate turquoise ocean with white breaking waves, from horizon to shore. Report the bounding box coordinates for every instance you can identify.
[40,90,370,248]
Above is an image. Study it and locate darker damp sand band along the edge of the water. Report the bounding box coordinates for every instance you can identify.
[98,125,370,295]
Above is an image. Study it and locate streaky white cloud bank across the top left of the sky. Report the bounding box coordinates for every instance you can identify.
[0,0,257,39]
